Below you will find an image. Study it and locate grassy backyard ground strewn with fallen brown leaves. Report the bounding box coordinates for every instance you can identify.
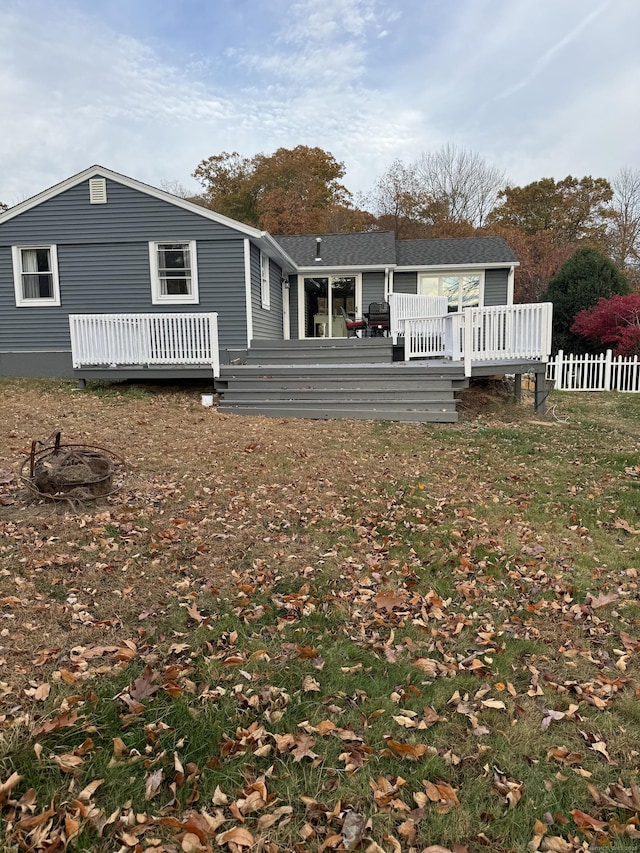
[0,380,640,853]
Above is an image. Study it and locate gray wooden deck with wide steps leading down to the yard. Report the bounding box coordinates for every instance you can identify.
[216,338,545,423]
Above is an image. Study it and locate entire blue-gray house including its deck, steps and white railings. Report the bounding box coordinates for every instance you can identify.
[0,166,552,422]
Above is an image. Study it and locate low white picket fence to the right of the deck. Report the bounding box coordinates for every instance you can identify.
[547,350,640,394]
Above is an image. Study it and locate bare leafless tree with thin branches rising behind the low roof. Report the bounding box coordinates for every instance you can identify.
[415,143,506,228]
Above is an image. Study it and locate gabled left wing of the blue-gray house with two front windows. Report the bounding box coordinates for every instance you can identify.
[0,166,295,377]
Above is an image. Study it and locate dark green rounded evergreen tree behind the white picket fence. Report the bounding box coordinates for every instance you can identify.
[543,246,630,352]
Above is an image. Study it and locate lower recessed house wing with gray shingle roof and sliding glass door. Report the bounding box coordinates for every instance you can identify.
[276,231,518,338]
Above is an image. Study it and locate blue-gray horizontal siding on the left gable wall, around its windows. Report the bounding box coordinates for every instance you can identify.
[0,176,252,375]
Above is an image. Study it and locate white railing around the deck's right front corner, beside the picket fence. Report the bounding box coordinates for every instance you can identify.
[404,302,553,376]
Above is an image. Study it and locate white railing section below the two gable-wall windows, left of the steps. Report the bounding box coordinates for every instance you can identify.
[69,312,220,376]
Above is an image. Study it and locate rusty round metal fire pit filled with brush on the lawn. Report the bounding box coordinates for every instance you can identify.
[20,432,124,502]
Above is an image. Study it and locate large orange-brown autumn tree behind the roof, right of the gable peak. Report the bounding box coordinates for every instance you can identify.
[193,145,362,234]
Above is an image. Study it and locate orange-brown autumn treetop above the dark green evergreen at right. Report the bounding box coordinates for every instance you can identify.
[488,175,613,246]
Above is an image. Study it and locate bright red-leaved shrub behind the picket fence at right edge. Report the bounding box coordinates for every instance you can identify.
[571,293,640,356]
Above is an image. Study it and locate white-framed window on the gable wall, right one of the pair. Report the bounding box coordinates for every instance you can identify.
[149,240,199,305]
